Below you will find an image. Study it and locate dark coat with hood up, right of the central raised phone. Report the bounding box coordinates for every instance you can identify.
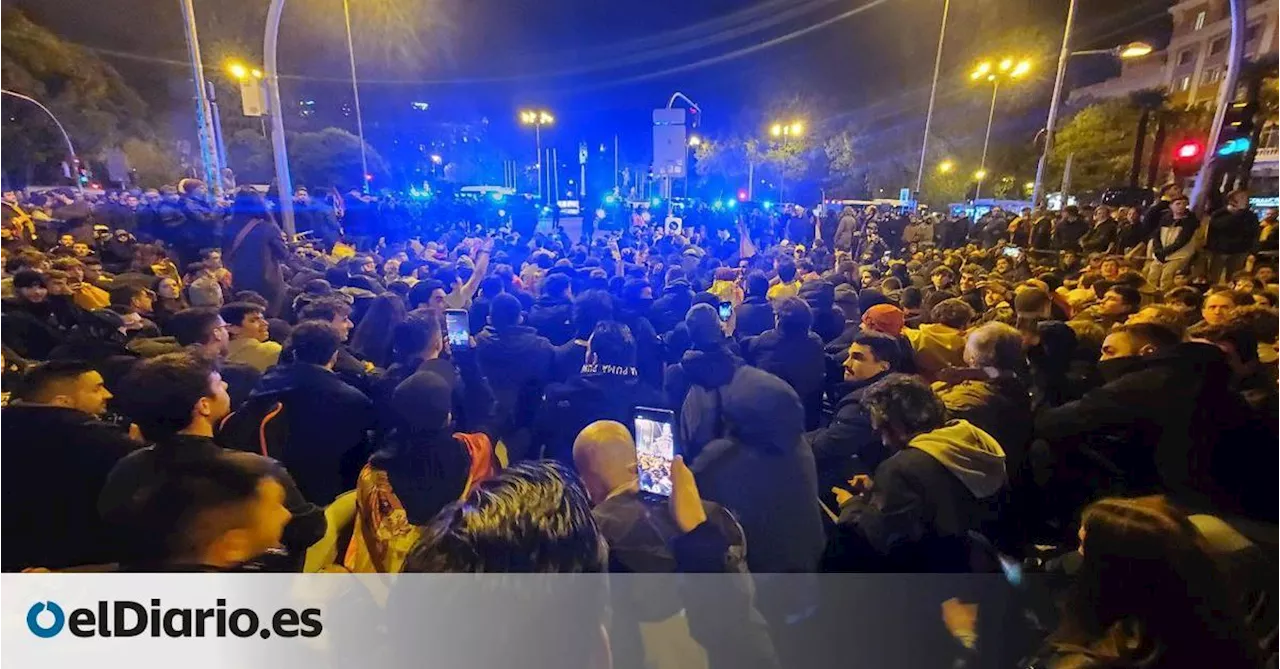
[684,367,823,573]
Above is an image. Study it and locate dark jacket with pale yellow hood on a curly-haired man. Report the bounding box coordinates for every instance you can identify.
[823,421,1009,573]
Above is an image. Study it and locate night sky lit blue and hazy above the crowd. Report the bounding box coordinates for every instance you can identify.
[0,0,1169,161]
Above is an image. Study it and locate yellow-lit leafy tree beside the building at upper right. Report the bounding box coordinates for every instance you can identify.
[1050,100,1140,192]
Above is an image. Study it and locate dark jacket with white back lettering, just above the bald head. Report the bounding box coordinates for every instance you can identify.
[534,366,667,464]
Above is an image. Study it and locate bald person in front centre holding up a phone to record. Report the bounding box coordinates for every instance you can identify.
[573,421,777,668]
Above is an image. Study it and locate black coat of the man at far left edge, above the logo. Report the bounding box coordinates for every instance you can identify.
[0,404,142,572]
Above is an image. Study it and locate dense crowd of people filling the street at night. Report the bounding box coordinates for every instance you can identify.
[0,179,1280,668]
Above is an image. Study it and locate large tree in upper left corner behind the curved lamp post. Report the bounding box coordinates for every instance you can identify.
[0,9,154,182]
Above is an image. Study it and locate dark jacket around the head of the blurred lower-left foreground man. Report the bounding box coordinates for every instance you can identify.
[97,435,328,567]
